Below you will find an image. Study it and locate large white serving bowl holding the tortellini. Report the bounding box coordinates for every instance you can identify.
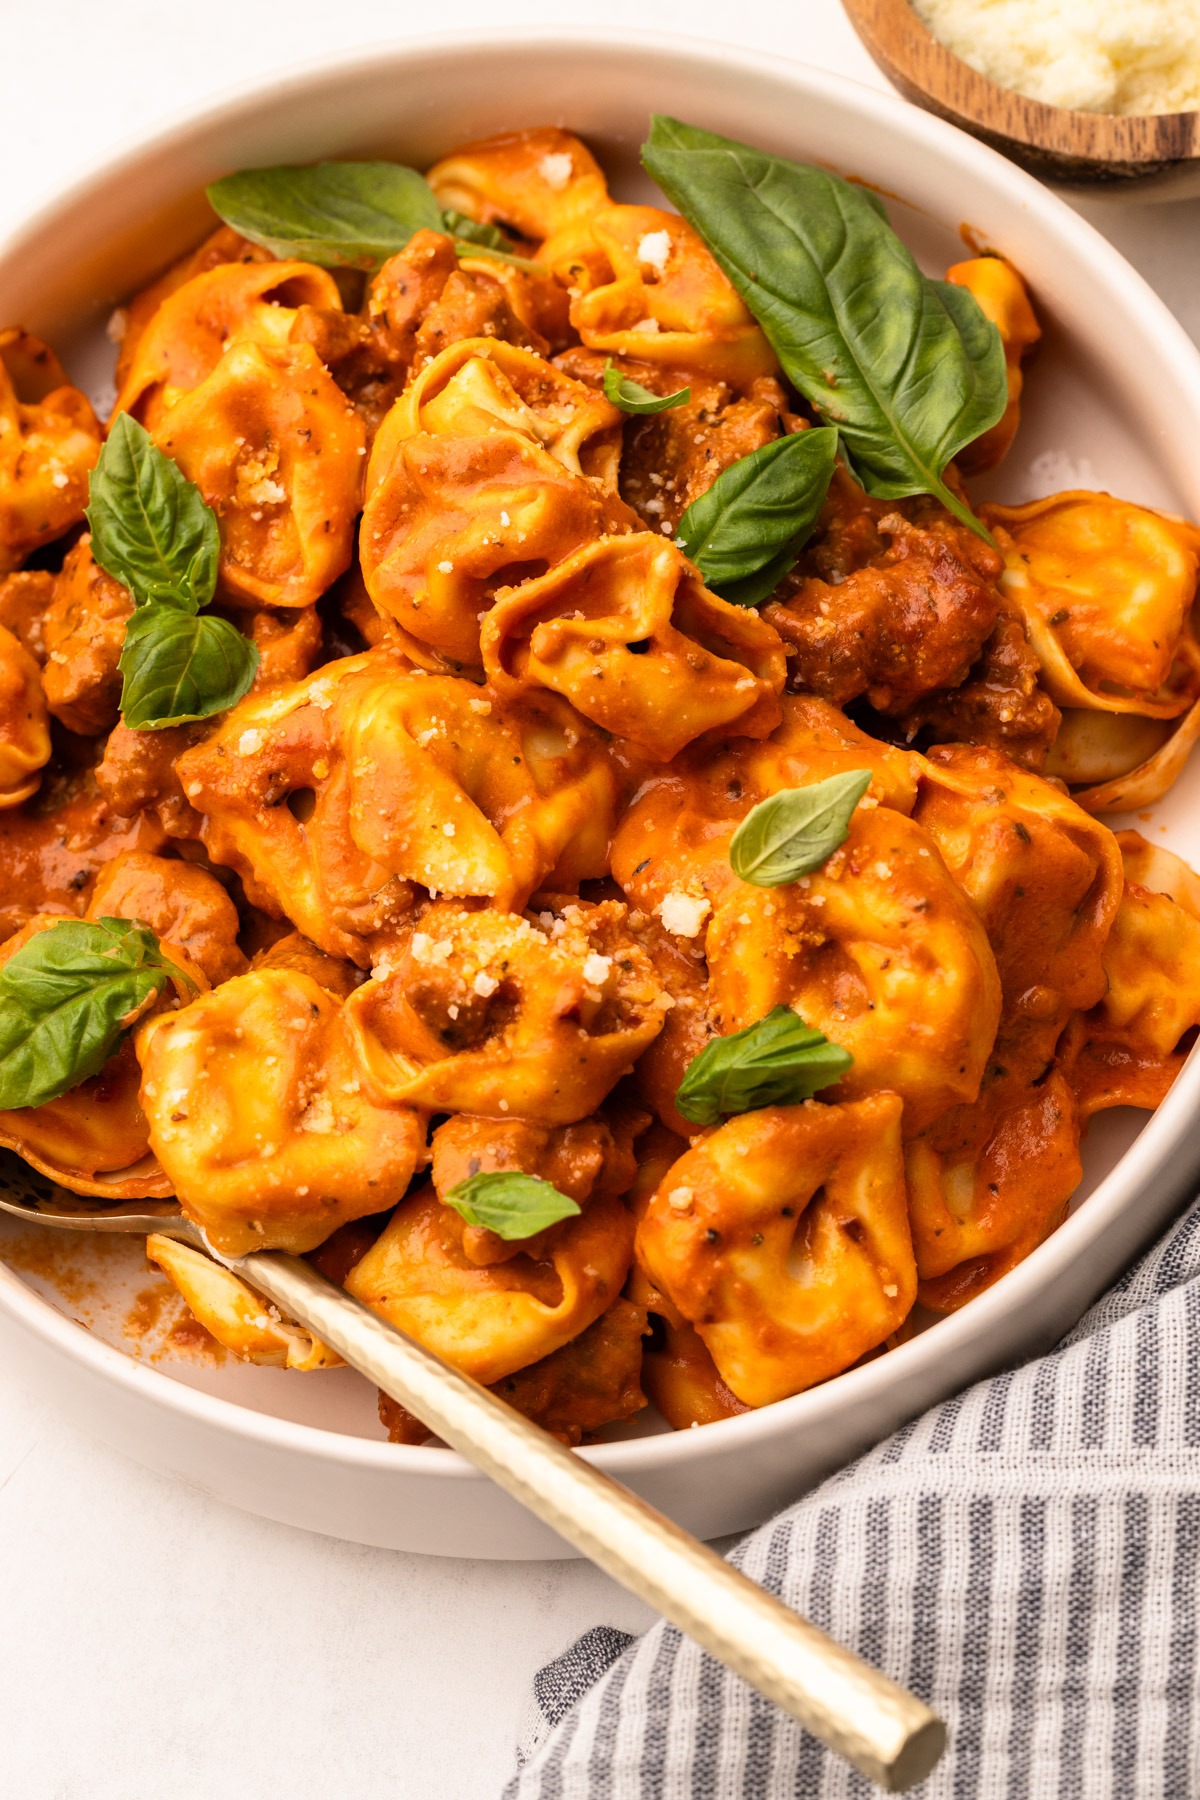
[0,31,1200,1557]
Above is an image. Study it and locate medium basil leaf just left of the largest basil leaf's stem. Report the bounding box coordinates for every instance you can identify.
[675,427,838,607]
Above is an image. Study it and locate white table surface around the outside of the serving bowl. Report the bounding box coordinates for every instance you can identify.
[0,0,1200,1800]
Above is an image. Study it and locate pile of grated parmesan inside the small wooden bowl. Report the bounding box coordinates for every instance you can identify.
[914,0,1200,113]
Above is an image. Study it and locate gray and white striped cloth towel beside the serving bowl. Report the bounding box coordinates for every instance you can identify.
[504,1201,1200,1800]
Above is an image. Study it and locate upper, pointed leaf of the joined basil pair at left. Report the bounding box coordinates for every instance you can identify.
[86,412,221,612]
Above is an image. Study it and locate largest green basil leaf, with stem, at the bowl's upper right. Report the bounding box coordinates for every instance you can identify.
[642,117,1007,538]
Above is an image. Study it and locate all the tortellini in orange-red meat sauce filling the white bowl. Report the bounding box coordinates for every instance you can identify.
[0,128,1200,1444]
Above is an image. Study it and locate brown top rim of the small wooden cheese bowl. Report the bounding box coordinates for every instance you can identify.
[842,0,1200,169]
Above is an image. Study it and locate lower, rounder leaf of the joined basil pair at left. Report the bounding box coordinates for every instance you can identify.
[121,603,259,731]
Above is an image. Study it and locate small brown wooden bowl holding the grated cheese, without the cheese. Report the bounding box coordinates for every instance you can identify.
[842,0,1200,200]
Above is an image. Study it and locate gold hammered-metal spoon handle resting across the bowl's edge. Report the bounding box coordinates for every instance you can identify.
[237,1251,946,1793]
